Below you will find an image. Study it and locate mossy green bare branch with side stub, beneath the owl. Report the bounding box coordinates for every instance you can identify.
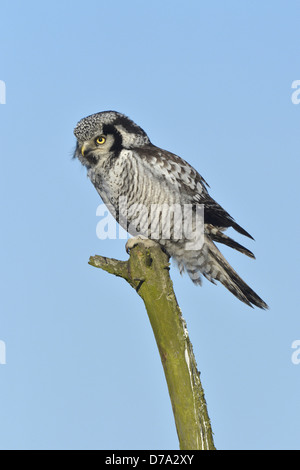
[89,240,215,450]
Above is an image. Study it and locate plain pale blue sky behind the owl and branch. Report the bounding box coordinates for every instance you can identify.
[0,0,300,449]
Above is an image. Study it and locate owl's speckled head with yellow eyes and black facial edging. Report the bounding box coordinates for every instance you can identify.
[74,111,150,168]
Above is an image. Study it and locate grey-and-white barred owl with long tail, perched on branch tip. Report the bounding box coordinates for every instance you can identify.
[74,111,268,309]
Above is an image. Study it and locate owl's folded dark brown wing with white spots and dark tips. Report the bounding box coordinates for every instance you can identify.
[137,144,253,243]
